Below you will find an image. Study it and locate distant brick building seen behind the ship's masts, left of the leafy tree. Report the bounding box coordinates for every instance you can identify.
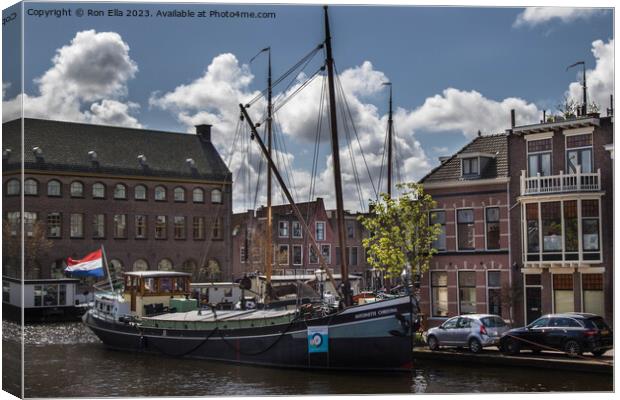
[232,197,367,278]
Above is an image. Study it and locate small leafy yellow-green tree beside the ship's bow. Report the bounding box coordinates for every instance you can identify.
[359,183,441,278]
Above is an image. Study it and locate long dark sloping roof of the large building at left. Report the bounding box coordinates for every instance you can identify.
[2,118,231,181]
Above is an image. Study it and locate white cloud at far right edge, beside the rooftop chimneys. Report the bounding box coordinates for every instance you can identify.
[566,39,614,112]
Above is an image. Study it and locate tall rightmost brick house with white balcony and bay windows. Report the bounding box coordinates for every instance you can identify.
[509,114,613,323]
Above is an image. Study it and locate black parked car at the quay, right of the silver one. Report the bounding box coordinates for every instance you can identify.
[500,313,613,357]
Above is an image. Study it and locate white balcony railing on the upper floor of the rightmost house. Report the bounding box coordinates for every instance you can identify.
[521,167,601,196]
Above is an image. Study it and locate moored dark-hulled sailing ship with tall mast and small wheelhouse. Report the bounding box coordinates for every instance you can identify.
[83,7,418,371]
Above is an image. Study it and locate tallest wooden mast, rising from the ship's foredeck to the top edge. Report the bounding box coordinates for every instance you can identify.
[323,6,351,306]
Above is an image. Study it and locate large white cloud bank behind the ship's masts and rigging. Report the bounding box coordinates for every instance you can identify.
[150,54,430,210]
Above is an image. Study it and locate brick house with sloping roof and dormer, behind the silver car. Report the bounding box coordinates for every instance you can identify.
[420,134,512,326]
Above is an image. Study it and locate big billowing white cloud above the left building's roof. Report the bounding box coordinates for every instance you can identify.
[3,30,141,127]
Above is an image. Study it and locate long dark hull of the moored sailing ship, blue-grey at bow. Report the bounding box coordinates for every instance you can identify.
[83,296,415,371]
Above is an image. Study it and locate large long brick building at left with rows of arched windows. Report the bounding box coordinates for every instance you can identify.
[2,118,232,280]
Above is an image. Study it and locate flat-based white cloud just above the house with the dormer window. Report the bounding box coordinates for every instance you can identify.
[399,88,540,138]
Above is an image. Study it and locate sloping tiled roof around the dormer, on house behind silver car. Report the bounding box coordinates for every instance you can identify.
[420,133,509,183]
